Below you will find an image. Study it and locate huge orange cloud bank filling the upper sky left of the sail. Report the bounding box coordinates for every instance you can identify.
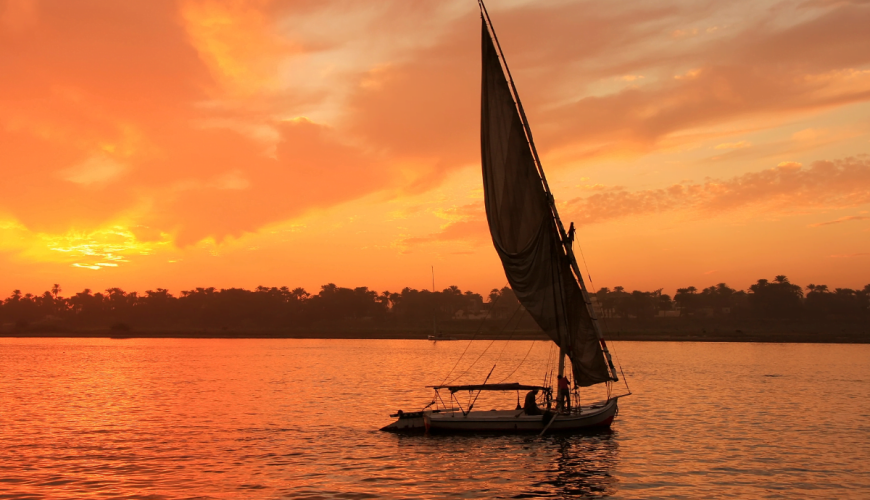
[0,0,488,250]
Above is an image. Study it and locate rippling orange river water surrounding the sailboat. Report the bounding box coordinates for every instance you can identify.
[0,339,870,499]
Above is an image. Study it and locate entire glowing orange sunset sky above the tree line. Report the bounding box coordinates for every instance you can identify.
[0,0,870,296]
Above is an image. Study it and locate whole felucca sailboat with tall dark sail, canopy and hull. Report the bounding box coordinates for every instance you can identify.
[382,0,620,433]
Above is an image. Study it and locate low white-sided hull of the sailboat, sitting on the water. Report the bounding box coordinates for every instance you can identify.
[381,398,619,434]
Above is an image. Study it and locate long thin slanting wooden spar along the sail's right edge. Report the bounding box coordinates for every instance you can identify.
[478,0,619,381]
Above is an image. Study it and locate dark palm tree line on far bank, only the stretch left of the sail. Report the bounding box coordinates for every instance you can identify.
[0,283,490,330]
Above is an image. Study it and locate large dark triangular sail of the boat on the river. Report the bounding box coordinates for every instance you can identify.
[480,12,616,386]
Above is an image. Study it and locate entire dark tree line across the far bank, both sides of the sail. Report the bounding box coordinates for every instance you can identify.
[0,275,870,331]
